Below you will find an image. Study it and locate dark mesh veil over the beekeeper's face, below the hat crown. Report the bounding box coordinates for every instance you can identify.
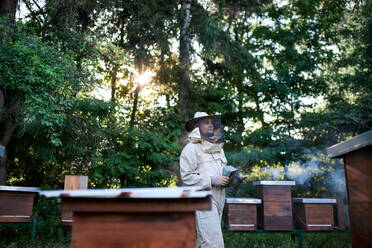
[194,115,225,143]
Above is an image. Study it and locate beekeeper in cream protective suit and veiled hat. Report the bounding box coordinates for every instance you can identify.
[180,112,229,248]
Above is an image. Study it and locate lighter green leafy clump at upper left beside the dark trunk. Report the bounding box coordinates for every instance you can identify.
[0,23,81,146]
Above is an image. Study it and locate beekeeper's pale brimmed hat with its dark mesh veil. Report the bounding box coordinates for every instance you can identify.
[185,112,225,143]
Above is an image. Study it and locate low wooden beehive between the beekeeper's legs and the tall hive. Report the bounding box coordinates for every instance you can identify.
[224,198,261,231]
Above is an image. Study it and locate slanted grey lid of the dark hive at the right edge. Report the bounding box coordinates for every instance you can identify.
[327,130,372,158]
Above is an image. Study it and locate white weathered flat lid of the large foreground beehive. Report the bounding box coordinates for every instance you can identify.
[40,186,211,199]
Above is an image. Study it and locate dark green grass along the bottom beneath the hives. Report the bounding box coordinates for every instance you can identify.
[0,226,351,248]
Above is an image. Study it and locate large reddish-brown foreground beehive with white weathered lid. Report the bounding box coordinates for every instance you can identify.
[40,187,212,248]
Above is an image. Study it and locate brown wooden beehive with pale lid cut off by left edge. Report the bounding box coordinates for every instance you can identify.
[0,186,40,222]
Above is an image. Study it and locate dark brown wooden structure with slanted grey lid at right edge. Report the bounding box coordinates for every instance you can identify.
[327,130,372,248]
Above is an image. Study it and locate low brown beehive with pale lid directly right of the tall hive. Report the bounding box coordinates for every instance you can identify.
[293,198,336,231]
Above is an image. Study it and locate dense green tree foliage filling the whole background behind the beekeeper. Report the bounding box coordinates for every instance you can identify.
[0,0,372,196]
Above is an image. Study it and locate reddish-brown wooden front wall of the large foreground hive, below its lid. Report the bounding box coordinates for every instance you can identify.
[71,212,195,248]
